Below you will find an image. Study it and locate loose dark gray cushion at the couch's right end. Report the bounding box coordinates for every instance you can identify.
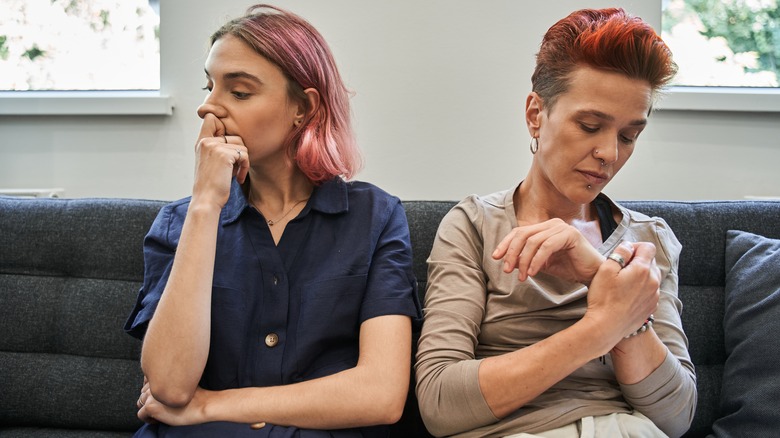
[713,230,780,436]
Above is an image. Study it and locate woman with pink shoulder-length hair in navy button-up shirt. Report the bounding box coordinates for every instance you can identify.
[125,5,419,437]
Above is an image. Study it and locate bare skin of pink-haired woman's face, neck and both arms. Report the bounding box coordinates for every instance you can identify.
[138,36,411,429]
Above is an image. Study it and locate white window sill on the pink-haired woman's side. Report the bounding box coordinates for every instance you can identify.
[0,91,173,116]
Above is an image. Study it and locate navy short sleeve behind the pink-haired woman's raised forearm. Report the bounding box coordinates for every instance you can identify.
[124,205,181,339]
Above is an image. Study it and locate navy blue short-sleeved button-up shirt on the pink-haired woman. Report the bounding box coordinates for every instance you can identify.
[125,178,420,437]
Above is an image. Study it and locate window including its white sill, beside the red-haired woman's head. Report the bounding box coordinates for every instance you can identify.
[661,0,780,111]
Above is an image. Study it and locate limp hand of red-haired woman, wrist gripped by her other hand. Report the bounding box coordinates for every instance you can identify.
[492,218,605,284]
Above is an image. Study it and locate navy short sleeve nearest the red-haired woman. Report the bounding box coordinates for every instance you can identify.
[360,198,422,325]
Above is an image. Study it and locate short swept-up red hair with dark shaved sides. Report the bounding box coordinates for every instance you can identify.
[531,8,677,110]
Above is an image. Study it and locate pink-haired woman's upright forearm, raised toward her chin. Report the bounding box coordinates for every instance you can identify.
[141,205,219,406]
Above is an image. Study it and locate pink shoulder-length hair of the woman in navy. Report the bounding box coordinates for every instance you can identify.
[211,4,362,184]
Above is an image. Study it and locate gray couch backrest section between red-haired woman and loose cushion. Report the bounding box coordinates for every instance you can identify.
[622,201,780,436]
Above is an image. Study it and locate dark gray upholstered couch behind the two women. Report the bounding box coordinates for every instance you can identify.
[0,197,780,437]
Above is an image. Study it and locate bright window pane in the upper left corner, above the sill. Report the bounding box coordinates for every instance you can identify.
[0,0,160,91]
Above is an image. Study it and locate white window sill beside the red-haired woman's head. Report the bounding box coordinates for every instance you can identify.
[656,87,780,112]
